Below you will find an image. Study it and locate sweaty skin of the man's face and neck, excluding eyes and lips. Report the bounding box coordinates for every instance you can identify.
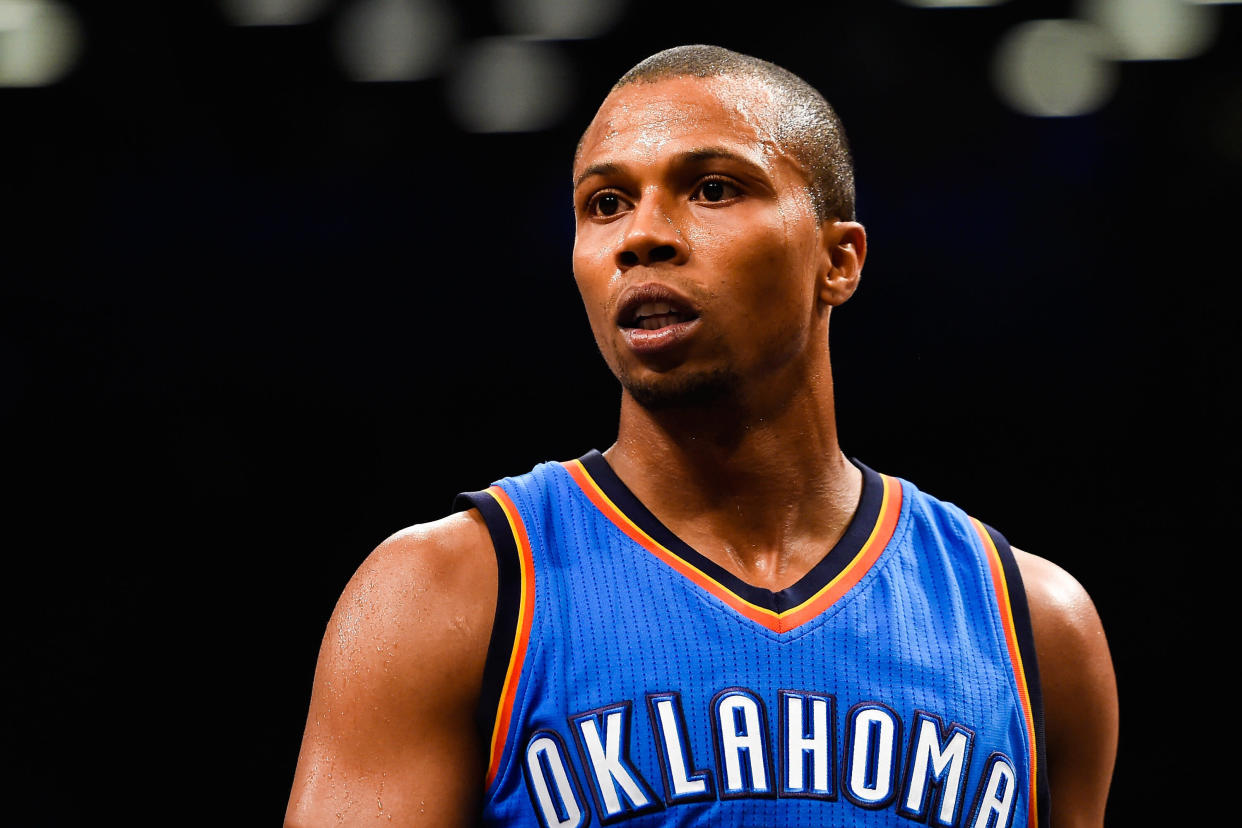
[574,78,866,590]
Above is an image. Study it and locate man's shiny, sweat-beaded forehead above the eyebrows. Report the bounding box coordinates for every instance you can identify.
[574,77,787,175]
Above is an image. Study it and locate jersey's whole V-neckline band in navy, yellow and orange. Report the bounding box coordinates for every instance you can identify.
[564,449,902,632]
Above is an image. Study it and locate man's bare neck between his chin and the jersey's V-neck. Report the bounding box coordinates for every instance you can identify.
[605,352,862,590]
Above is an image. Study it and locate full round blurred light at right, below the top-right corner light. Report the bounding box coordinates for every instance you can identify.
[994,20,1117,118]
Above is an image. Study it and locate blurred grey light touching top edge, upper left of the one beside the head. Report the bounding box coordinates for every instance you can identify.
[337,0,456,81]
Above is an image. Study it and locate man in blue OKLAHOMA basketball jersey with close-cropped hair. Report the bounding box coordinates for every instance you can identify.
[287,46,1117,828]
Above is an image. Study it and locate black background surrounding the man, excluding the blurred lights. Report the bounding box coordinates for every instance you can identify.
[0,0,1242,824]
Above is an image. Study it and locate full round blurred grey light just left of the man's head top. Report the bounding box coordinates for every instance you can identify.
[448,37,574,133]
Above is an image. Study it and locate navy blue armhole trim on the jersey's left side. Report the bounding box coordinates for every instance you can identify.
[453,492,522,761]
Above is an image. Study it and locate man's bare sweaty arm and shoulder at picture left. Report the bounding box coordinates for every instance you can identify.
[284,510,497,828]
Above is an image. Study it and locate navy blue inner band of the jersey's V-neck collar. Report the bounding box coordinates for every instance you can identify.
[579,449,884,612]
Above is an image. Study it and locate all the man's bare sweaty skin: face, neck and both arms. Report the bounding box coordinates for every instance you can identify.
[286,77,1118,828]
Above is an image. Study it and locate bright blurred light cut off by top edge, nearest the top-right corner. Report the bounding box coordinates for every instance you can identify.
[1078,0,1220,61]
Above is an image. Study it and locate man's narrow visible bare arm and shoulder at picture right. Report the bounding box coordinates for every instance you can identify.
[1013,550,1118,828]
